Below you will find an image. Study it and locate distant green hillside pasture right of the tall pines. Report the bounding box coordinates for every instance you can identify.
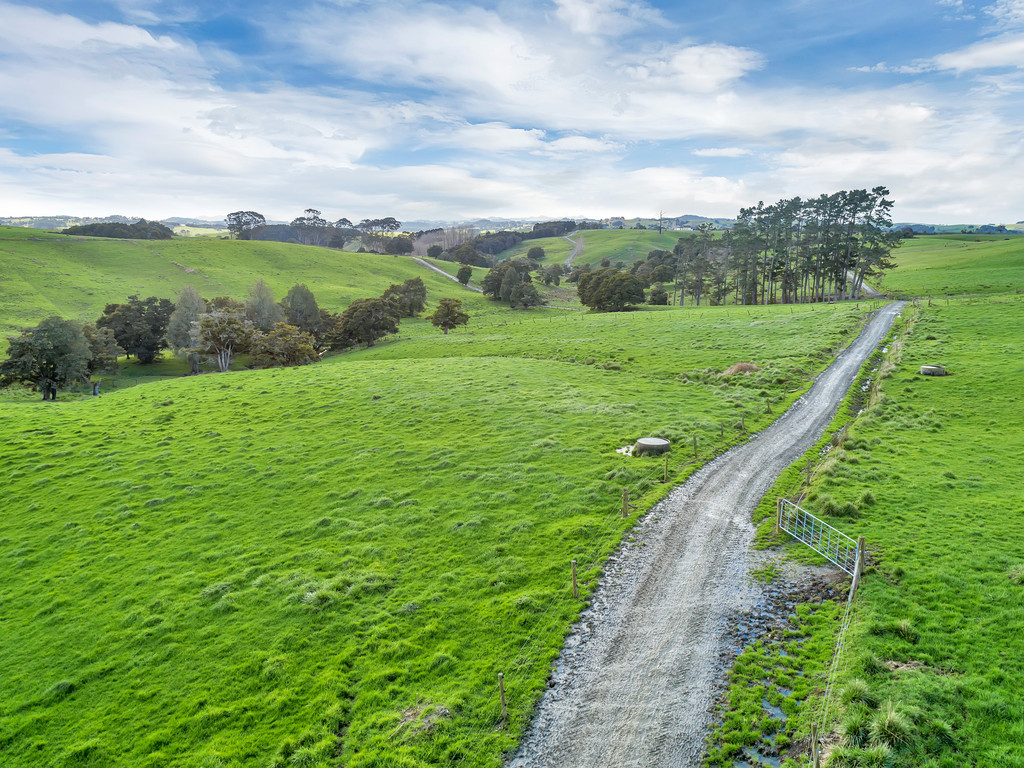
[881,234,1024,297]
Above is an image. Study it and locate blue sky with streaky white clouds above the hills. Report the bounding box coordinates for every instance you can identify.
[0,0,1024,224]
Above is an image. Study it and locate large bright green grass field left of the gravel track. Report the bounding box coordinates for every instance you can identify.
[0,296,863,767]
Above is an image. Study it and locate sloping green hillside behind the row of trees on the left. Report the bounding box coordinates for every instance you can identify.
[0,226,483,347]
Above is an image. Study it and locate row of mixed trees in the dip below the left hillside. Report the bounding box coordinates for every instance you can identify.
[0,278,469,400]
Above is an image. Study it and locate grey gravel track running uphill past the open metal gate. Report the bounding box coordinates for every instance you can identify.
[509,303,903,768]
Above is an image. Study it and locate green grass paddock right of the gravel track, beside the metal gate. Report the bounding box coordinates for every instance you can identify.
[709,294,1024,768]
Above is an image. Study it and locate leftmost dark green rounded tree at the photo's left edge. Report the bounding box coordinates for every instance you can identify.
[0,316,92,400]
